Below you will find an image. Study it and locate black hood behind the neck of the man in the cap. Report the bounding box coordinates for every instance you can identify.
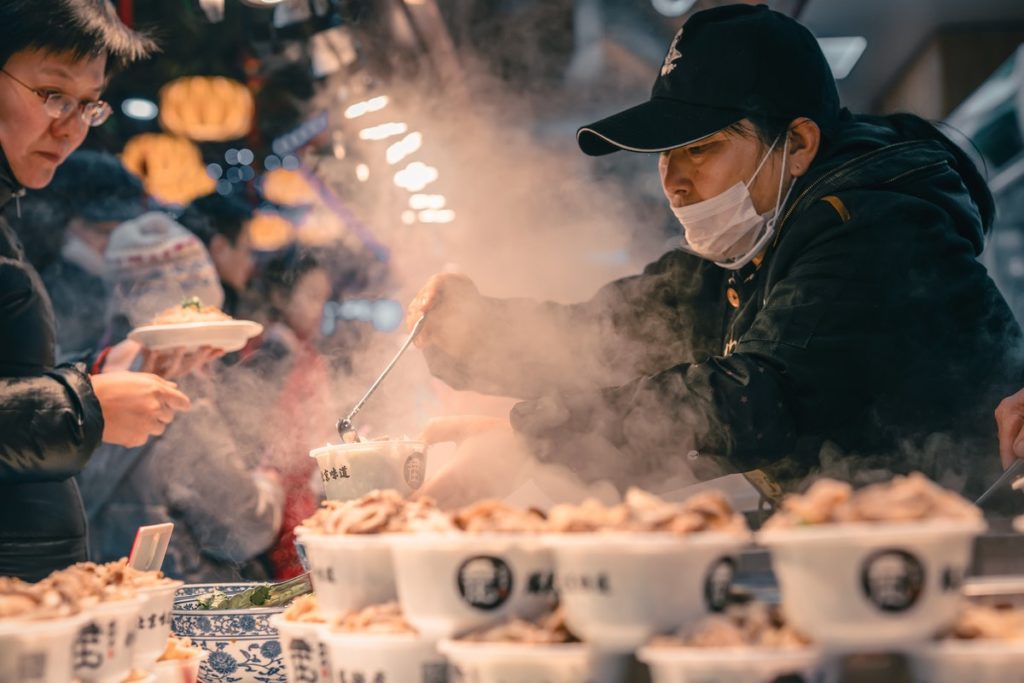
[791,110,995,254]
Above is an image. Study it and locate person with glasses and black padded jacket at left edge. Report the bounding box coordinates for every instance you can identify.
[0,0,195,581]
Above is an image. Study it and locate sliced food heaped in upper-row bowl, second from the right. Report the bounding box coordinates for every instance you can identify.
[548,488,748,535]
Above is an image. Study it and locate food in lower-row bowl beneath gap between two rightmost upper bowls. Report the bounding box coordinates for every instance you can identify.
[650,602,809,649]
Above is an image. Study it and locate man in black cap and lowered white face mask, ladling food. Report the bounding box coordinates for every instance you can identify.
[410,5,1021,499]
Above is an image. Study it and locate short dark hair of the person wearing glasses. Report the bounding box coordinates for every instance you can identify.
[0,0,157,69]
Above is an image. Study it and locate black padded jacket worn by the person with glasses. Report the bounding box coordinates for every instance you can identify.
[0,154,103,581]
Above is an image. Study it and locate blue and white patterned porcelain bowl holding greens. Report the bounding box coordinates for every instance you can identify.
[171,584,288,683]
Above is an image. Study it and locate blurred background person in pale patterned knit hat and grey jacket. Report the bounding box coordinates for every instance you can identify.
[79,212,284,583]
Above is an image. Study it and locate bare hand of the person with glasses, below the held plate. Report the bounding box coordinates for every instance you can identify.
[92,372,191,447]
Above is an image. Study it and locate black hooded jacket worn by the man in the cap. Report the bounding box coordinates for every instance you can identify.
[426,113,1021,498]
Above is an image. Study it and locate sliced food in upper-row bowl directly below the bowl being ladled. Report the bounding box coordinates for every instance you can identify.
[302,489,455,536]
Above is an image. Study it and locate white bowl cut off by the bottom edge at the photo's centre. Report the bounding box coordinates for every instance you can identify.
[437,640,593,683]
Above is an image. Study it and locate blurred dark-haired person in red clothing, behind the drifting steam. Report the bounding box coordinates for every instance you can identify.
[224,247,338,579]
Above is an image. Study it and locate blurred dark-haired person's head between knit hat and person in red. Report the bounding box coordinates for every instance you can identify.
[178,193,254,317]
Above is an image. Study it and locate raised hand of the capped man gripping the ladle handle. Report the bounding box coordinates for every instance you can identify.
[406,272,481,351]
